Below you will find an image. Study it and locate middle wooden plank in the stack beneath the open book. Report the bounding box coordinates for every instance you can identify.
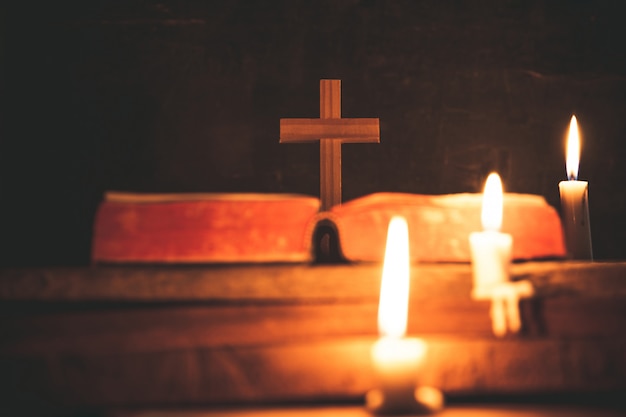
[0,297,626,355]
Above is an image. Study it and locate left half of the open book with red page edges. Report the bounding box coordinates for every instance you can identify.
[92,193,320,263]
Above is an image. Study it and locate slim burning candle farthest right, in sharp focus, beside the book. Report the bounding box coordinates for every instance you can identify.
[559,116,593,259]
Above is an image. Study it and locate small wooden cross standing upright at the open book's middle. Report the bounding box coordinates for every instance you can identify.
[280,80,380,210]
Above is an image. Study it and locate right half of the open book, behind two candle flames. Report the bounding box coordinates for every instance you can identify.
[318,193,566,262]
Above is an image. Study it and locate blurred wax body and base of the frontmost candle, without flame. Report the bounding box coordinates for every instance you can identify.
[365,337,444,415]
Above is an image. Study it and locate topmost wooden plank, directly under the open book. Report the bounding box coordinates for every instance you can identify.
[0,262,626,302]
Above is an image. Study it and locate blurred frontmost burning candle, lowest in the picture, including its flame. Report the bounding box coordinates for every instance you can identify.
[367,217,443,414]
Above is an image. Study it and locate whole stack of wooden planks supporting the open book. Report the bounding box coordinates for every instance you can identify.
[0,262,626,415]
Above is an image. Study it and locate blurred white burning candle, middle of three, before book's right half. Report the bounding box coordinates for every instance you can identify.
[469,173,513,299]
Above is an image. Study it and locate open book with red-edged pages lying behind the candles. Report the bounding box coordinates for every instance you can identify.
[92,192,566,263]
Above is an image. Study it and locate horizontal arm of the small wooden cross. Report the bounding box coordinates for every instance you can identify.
[280,118,380,143]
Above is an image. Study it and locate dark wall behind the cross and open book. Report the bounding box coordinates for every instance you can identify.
[0,0,626,266]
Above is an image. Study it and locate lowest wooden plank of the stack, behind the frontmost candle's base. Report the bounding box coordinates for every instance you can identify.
[0,337,626,406]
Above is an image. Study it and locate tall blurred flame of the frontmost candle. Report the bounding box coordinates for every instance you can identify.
[378,216,410,337]
